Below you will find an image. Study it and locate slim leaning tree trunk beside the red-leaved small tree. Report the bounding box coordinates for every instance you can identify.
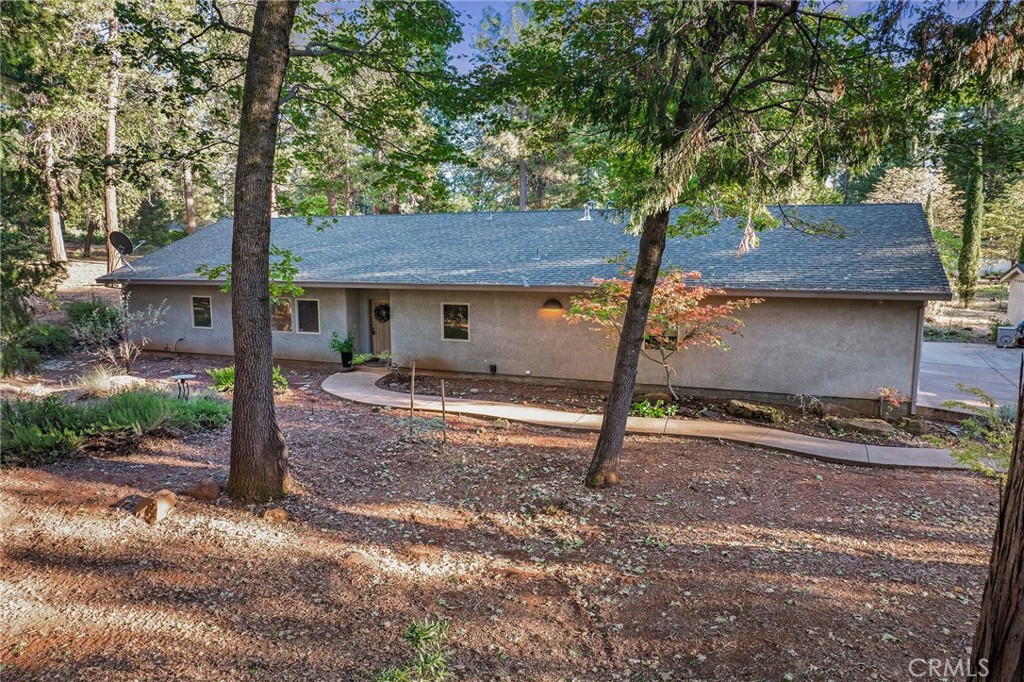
[587,211,669,487]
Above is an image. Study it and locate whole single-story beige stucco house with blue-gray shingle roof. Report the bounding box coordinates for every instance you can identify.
[99,204,951,407]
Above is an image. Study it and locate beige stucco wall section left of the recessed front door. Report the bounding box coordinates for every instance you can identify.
[129,285,349,361]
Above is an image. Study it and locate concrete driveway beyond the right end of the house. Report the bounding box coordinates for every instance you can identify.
[918,341,1024,408]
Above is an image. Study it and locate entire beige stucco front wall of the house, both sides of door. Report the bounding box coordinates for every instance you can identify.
[123,285,923,400]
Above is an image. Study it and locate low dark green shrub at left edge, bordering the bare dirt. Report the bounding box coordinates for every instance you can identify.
[0,395,85,467]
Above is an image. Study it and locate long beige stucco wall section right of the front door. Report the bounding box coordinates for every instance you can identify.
[391,291,922,399]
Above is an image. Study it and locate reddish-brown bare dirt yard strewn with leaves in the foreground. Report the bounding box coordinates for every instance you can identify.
[0,356,996,682]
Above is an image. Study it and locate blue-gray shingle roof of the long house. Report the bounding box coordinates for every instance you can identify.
[99,204,950,299]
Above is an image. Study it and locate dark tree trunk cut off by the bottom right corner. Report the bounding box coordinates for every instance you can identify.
[971,360,1024,682]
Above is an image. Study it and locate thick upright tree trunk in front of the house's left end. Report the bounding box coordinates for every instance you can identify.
[227,0,298,502]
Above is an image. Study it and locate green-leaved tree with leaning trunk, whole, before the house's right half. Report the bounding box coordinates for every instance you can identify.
[499,1,912,486]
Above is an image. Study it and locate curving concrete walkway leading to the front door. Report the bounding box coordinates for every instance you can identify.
[323,370,964,469]
